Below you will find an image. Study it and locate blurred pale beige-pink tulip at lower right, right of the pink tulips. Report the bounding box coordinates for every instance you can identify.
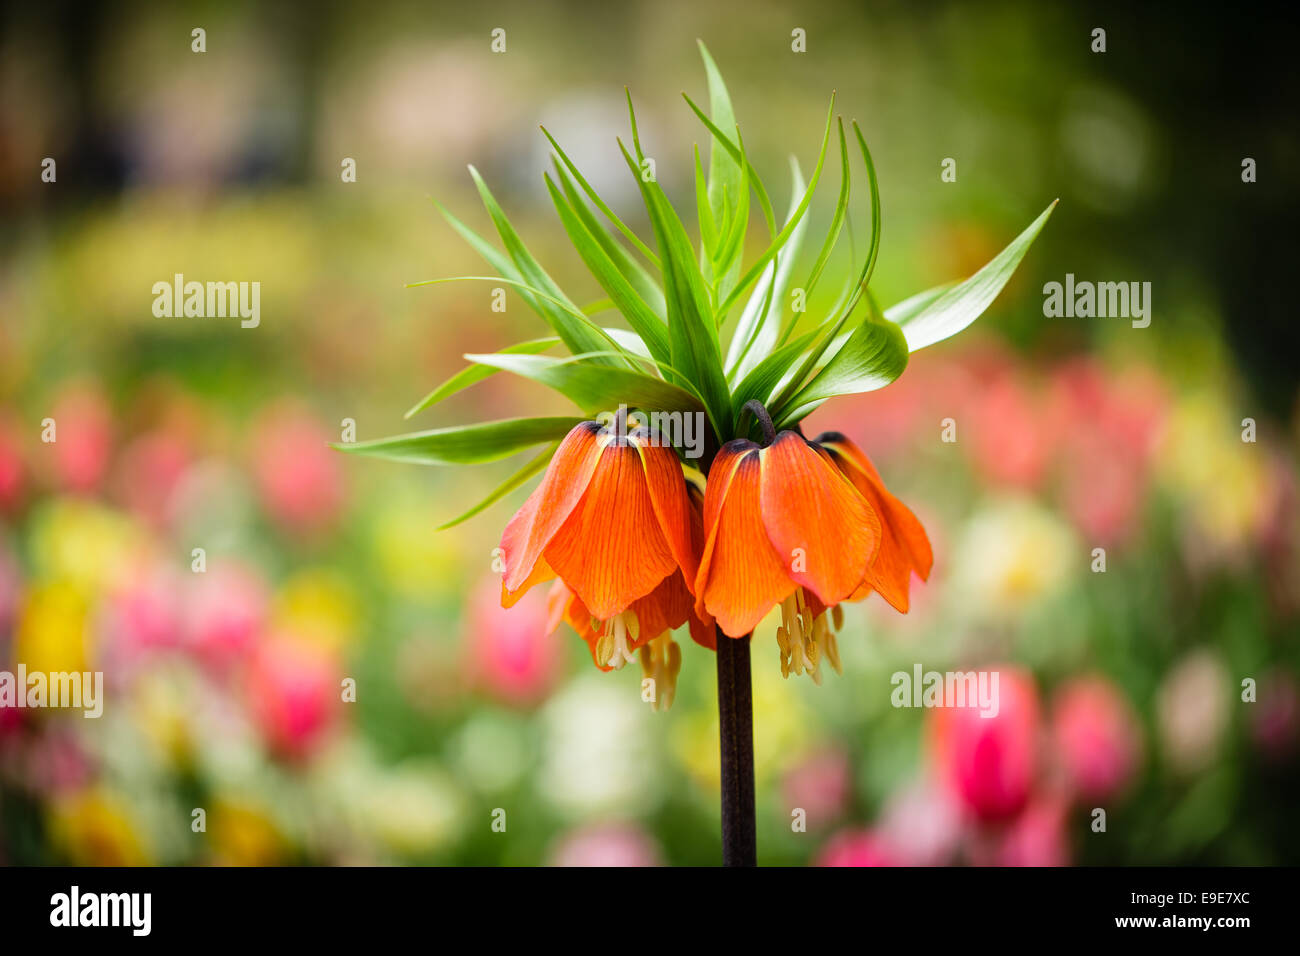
[1156,649,1231,773]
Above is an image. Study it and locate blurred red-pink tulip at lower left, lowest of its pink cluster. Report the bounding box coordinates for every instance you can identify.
[246,637,342,760]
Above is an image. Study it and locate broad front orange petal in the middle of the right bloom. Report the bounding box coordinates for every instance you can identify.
[759,432,880,605]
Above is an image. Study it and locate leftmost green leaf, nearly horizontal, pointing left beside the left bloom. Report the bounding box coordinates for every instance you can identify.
[330,418,585,464]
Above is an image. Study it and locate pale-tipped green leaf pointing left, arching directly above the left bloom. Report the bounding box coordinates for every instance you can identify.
[465,352,703,415]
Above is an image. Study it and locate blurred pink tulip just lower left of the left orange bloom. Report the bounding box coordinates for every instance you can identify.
[464,576,563,706]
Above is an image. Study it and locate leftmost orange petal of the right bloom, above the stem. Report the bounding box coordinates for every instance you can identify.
[696,440,796,637]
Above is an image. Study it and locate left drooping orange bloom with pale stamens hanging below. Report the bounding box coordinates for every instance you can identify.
[501,421,712,698]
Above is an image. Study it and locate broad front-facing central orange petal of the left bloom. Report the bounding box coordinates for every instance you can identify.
[545,441,677,620]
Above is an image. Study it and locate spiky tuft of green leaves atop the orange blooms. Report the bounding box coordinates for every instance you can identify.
[334,43,1056,527]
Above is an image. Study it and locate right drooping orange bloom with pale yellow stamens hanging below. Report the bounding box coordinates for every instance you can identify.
[694,431,931,682]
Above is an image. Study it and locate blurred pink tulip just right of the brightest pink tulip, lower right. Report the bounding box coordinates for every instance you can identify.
[1052,676,1141,801]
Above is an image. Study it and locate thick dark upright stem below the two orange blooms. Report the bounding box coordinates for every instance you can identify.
[716,630,758,866]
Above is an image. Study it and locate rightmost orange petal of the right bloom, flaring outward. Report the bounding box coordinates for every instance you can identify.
[819,433,935,614]
